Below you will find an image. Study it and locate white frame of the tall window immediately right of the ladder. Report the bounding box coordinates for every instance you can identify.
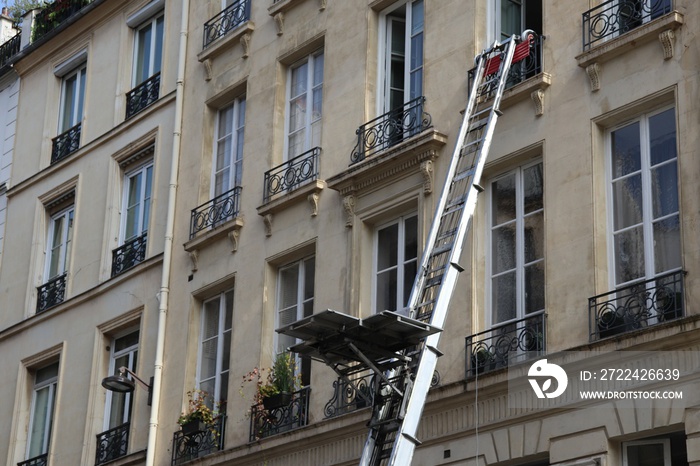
[484,159,547,328]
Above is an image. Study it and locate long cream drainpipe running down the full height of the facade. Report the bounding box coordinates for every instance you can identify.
[146,0,190,466]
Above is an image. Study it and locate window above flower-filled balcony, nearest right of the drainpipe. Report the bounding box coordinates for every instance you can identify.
[197,290,233,412]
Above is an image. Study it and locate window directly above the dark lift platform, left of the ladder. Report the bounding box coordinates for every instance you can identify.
[372,214,418,314]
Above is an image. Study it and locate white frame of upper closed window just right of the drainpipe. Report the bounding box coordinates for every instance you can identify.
[210,96,246,199]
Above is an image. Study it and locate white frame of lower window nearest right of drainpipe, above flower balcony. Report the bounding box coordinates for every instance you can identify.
[197,288,235,411]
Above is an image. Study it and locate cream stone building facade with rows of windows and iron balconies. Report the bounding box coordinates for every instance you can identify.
[0,0,700,466]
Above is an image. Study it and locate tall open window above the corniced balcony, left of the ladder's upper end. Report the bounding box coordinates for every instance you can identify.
[378,0,423,114]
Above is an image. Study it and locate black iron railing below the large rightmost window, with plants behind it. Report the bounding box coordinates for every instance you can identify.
[588,270,685,341]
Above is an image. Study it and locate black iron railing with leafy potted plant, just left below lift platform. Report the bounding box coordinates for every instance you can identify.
[250,387,311,442]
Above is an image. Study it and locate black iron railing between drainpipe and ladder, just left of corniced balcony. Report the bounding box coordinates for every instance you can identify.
[263,147,321,203]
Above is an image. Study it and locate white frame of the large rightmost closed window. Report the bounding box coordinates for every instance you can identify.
[605,105,682,289]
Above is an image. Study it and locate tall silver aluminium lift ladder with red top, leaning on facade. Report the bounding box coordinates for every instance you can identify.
[360,31,533,466]
